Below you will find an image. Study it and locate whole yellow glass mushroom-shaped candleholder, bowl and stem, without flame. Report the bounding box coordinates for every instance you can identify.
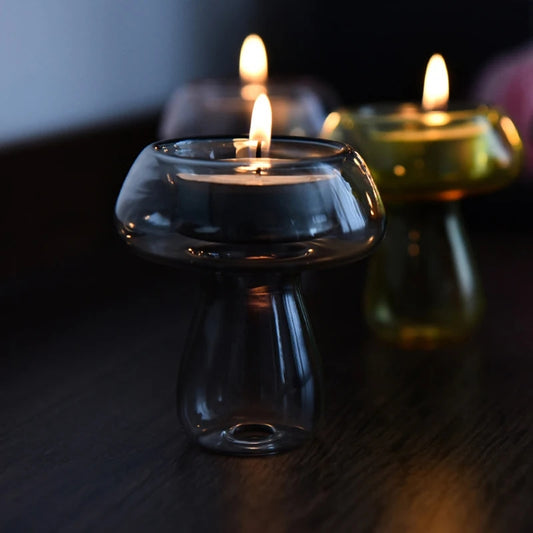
[322,104,523,348]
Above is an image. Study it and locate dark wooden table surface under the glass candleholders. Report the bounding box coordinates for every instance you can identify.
[0,118,533,533]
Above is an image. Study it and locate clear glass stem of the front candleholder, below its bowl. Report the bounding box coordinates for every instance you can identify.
[177,272,321,455]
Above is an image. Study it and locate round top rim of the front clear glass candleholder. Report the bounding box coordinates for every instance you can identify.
[150,135,356,171]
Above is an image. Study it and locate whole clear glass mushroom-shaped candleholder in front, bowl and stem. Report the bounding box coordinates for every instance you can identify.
[116,137,384,455]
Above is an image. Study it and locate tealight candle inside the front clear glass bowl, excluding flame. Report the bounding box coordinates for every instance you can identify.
[172,162,364,242]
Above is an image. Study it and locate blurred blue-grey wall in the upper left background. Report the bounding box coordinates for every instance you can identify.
[0,0,253,146]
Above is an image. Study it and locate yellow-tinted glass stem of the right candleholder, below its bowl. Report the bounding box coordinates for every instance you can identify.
[364,201,484,349]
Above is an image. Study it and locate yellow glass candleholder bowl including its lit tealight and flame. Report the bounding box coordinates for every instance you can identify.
[321,54,522,201]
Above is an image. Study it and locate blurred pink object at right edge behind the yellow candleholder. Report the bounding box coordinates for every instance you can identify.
[472,42,533,178]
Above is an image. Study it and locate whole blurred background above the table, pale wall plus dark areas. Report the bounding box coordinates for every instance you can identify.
[4,0,533,279]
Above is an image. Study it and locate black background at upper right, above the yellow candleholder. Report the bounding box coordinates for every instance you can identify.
[257,0,533,105]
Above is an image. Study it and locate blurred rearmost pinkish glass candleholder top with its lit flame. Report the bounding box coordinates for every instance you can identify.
[159,34,337,139]
